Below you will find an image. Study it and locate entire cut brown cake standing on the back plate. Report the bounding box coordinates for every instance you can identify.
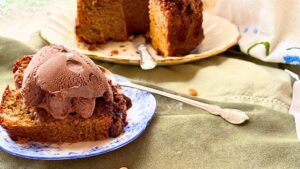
[75,0,204,56]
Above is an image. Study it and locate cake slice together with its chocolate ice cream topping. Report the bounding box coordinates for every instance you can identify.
[0,45,131,142]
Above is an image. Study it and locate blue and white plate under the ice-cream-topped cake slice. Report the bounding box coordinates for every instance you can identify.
[0,76,156,160]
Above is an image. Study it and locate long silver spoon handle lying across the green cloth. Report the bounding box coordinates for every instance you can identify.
[119,82,249,124]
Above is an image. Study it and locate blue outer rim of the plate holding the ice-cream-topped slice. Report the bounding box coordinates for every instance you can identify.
[0,74,157,161]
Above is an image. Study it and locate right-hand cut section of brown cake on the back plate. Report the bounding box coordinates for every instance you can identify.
[149,0,204,56]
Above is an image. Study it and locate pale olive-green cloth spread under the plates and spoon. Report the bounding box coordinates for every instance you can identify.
[0,34,300,169]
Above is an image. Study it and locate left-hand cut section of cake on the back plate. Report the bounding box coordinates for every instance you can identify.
[75,0,149,44]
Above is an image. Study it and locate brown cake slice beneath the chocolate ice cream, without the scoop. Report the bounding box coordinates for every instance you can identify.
[0,45,131,143]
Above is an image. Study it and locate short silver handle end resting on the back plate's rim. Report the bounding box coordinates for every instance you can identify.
[138,44,157,70]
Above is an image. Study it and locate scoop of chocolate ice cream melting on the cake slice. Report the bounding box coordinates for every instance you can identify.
[21,45,111,119]
